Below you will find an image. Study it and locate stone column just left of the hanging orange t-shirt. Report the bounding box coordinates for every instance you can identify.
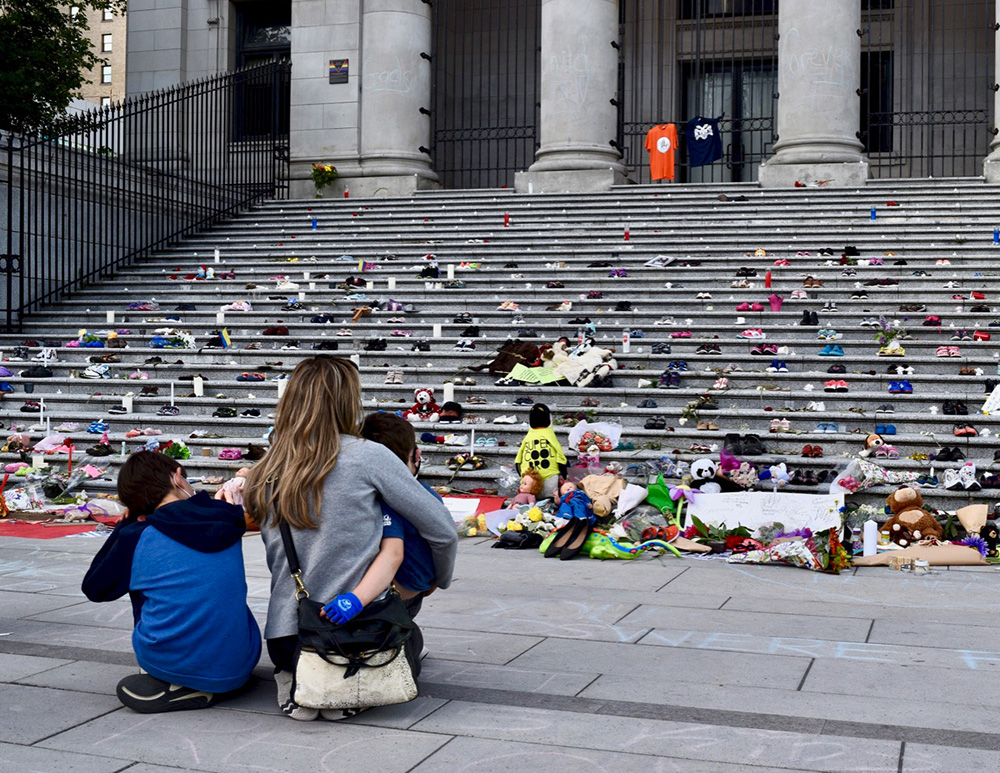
[515,0,625,193]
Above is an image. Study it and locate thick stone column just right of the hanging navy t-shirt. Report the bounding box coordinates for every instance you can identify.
[759,0,868,188]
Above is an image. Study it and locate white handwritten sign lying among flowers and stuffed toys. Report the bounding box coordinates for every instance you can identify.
[688,491,844,531]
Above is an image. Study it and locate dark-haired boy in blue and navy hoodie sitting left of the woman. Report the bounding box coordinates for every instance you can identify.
[83,451,261,714]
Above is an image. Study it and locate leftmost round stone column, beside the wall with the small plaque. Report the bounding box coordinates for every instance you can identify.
[351,0,438,196]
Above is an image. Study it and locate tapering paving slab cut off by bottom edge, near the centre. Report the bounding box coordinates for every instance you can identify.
[415,738,816,773]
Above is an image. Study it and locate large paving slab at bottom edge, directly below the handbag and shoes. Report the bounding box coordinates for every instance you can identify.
[39,701,449,773]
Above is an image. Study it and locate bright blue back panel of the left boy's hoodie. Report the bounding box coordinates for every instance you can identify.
[129,528,261,693]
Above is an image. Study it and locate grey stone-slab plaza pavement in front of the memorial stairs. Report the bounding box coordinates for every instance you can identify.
[0,537,1000,773]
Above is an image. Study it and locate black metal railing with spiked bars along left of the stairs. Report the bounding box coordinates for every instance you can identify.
[0,62,291,331]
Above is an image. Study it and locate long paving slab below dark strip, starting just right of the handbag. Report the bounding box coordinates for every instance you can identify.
[414,701,900,773]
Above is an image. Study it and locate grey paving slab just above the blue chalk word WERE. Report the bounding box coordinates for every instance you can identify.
[619,604,871,641]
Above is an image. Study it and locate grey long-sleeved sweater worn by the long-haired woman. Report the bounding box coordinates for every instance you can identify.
[261,437,458,639]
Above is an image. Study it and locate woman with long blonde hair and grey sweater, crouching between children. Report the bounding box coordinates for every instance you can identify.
[243,356,457,719]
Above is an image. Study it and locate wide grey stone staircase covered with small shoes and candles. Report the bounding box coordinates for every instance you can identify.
[0,179,1000,508]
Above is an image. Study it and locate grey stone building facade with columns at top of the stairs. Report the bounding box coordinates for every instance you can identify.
[128,0,1000,195]
